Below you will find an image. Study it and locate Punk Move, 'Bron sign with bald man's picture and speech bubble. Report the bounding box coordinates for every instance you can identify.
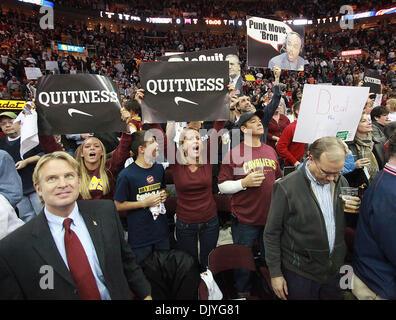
[246,17,308,71]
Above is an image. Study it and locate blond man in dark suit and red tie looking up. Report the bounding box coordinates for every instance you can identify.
[0,152,151,300]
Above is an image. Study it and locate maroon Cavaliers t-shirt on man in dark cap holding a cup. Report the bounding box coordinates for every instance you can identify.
[218,142,282,226]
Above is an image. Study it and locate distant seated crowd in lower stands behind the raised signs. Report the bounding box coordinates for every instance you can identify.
[0,7,396,104]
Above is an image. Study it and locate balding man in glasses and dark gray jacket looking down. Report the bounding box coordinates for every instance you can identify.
[264,137,360,300]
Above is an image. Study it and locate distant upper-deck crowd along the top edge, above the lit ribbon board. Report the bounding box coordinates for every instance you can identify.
[54,0,393,19]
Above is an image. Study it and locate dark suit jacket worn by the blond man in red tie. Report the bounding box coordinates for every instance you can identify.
[0,200,151,300]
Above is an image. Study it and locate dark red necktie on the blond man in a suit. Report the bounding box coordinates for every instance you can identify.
[63,218,101,300]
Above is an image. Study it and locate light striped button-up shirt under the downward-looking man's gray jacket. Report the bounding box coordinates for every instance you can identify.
[305,162,335,252]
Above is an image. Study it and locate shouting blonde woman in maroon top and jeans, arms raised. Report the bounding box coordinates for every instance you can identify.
[135,85,230,271]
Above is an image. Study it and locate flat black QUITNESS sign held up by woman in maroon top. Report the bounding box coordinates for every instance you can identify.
[139,61,229,123]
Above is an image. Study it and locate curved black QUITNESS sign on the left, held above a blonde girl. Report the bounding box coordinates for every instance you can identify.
[35,74,125,135]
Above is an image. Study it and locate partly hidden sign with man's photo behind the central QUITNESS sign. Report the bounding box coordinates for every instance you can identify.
[160,47,243,96]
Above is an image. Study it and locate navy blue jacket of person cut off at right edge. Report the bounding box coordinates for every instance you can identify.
[353,164,396,299]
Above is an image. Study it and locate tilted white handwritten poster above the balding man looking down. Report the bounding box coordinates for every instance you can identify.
[293,84,369,143]
